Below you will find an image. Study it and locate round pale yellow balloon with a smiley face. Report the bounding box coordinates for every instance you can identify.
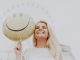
[3,14,35,41]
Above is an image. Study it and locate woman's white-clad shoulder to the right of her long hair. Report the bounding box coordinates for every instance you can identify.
[60,44,75,60]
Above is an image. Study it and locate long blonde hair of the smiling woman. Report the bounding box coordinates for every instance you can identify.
[33,21,62,60]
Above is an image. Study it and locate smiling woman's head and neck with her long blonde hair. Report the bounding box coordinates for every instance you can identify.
[33,21,62,60]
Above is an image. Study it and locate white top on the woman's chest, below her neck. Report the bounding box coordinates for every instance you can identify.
[24,48,55,60]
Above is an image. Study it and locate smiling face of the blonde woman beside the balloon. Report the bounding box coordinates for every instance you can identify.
[35,22,48,39]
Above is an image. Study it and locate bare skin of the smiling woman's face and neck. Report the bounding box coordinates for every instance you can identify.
[34,22,48,48]
